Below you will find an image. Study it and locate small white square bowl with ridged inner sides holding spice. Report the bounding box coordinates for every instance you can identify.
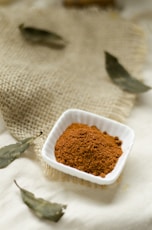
[42,109,134,185]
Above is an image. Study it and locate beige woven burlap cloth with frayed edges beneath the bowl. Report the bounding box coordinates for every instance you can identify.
[0,1,145,185]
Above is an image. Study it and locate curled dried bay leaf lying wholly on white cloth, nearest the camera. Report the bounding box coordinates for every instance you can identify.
[14,181,67,222]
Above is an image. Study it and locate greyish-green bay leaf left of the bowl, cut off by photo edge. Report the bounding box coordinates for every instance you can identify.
[0,133,42,168]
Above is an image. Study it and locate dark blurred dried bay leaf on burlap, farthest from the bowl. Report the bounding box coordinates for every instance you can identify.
[19,24,67,49]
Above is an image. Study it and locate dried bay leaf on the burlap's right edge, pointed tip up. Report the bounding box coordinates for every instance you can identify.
[105,52,152,94]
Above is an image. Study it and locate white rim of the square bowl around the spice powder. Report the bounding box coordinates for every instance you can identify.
[41,108,135,185]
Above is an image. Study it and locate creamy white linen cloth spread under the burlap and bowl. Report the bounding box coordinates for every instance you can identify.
[0,1,152,230]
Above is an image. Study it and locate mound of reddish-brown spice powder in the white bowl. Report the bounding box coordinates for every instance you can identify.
[55,123,122,177]
